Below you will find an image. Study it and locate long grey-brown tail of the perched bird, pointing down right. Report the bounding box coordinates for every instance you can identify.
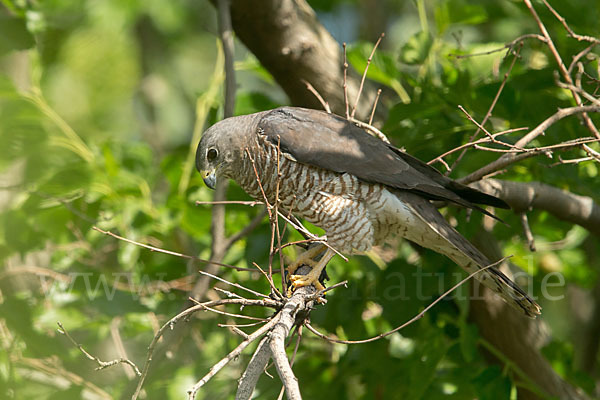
[397,192,541,318]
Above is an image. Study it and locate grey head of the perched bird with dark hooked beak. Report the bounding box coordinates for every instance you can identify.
[196,113,262,189]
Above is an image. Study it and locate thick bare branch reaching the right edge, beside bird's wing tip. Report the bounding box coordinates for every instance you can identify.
[471,179,600,236]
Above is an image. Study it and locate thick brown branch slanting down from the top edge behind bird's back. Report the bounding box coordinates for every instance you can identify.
[223,0,384,119]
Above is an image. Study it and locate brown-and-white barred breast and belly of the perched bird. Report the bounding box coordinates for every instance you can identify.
[224,136,418,253]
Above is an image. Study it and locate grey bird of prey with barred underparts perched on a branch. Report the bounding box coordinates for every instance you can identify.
[196,107,540,317]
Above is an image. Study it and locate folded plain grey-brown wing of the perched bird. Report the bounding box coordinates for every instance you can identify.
[258,107,508,212]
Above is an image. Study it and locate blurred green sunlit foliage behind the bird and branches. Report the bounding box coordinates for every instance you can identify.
[0,0,600,399]
